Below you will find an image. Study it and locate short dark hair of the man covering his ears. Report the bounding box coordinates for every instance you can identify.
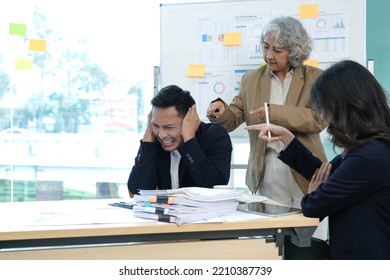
[151,85,195,118]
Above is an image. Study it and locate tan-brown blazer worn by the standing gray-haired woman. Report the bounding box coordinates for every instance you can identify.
[211,65,327,194]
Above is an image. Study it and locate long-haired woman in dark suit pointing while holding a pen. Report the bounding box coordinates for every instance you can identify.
[246,61,390,260]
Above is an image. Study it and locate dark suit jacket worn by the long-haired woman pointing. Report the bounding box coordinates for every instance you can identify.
[279,139,390,260]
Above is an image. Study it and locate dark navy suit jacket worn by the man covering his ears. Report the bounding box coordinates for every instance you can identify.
[127,122,233,194]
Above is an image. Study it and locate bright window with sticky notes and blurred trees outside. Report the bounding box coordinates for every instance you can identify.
[0,0,241,202]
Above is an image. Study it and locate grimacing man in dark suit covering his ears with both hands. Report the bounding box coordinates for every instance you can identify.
[127,85,232,194]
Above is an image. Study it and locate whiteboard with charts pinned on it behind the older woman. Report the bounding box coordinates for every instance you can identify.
[160,0,366,126]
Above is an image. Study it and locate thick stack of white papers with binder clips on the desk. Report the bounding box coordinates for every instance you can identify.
[133,187,243,224]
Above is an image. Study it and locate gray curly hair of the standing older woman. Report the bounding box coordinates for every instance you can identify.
[260,16,313,68]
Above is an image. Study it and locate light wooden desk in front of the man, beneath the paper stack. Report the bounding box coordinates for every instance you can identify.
[0,199,319,260]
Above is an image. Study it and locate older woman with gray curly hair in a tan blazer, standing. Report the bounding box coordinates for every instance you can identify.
[207,17,327,212]
